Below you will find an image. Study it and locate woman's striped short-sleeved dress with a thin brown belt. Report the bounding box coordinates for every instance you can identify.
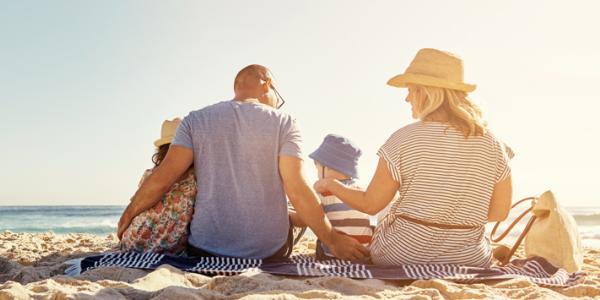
[371,122,513,267]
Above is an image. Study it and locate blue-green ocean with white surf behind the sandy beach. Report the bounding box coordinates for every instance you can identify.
[0,206,600,248]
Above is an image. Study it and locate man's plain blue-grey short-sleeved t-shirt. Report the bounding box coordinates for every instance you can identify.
[172,101,301,258]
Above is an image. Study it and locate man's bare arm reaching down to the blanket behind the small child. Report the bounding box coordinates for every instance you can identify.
[279,155,368,260]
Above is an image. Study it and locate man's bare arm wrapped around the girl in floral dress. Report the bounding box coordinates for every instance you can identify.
[117,145,194,239]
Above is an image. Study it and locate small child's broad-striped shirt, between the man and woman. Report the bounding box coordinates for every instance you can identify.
[319,180,373,256]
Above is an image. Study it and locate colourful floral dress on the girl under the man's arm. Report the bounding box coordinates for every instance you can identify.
[119,170,196,254]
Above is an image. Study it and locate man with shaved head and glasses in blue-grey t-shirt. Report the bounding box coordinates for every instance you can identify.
[118,65,368,260]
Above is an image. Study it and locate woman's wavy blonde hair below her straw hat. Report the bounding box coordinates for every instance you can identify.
[411,85,487,137]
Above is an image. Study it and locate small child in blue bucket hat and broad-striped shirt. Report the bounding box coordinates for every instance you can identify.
[309,134,373,260]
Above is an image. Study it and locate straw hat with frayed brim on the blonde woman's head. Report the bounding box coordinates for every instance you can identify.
[388,48,476,93]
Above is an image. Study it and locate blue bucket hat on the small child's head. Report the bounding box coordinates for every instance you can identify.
[308,134,362,178]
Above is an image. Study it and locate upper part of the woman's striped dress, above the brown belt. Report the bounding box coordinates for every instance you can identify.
[380,122,509,226]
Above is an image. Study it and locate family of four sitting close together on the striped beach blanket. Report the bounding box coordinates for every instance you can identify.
[118,49,512,267]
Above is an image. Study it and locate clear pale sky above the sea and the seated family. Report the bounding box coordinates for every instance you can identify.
[0,0,600,206]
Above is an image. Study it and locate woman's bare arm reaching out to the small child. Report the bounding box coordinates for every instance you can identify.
[314,158,400,215]
